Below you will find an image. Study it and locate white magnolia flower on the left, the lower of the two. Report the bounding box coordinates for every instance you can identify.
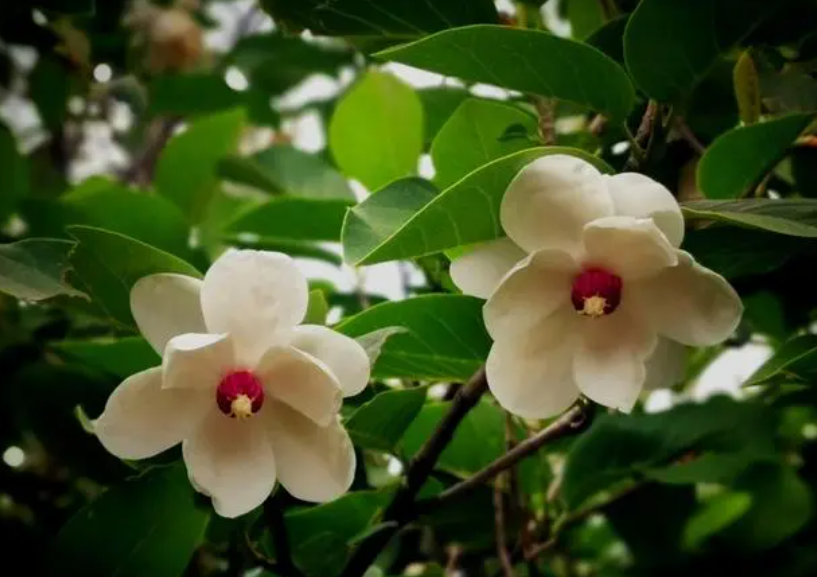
[95,250,369,517]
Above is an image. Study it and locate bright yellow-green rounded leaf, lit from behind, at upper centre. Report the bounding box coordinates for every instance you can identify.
[329,71,423,190]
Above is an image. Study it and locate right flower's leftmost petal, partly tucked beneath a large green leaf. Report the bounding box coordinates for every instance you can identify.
[449,238,527,299]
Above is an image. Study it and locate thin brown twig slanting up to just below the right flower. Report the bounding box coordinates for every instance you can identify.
[419,404,587,511]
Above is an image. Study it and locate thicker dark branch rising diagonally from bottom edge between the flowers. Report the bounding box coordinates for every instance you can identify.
[341,368,488,577]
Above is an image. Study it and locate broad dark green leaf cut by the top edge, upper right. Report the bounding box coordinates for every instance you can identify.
[624,0,780,102]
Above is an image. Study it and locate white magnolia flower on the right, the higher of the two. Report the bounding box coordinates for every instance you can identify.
[451,155,743,418]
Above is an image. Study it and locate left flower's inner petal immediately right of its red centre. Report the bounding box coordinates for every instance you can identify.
[255,347,343,425]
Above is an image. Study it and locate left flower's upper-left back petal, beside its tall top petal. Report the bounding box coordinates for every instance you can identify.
[130,274,207,355]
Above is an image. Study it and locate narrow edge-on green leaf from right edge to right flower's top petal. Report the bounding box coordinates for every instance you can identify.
[682,199,817,238]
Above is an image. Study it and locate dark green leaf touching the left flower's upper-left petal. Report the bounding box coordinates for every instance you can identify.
[68,226,201,327]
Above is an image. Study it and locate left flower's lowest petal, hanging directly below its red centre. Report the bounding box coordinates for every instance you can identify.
[182,404,275,518]
